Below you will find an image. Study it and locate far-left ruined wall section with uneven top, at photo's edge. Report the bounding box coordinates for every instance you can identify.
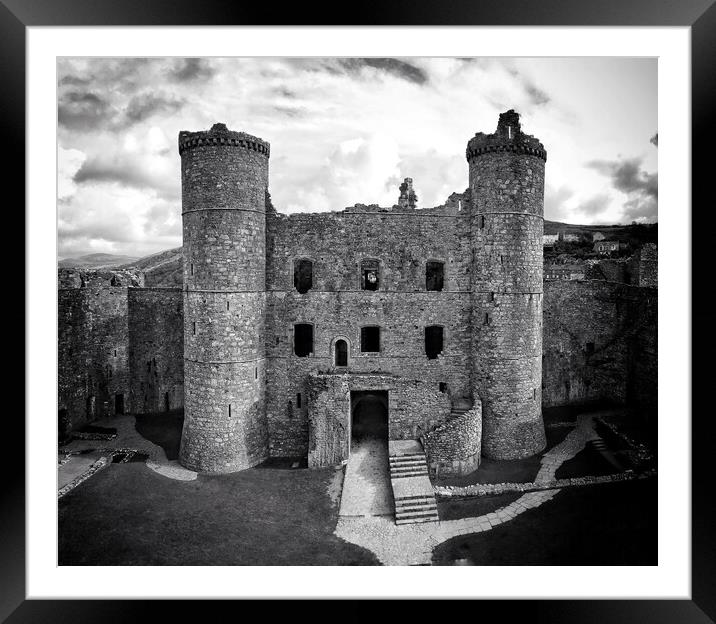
[57,269,142,433]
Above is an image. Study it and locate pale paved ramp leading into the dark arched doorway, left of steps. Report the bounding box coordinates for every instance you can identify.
[338,438,395,521]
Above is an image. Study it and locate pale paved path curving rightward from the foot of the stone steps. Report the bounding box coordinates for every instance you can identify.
[335,414,598,565]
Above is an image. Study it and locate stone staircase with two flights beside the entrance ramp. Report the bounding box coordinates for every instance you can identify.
[388,440,439,524]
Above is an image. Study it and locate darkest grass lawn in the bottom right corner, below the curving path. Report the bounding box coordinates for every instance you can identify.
[433,478,658,565]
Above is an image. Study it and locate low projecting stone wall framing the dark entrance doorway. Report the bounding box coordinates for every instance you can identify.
[302,373,450,467]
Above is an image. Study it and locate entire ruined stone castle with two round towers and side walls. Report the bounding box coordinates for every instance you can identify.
[59,110,656,474]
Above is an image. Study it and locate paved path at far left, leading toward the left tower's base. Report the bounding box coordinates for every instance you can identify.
[57,414,197,490]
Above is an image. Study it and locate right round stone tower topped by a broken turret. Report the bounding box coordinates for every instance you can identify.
[467,110,547,459]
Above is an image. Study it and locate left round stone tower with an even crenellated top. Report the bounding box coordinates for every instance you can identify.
[179,124,269,473]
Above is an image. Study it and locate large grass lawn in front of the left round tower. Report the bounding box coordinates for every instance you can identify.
[59,458,378,565]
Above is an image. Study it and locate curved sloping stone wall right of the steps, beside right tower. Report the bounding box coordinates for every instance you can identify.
[421,400,482,477]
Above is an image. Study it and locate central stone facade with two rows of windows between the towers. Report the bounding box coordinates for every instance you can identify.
[266,206,471,455]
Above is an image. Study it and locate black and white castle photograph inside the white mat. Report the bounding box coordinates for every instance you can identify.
[56,56,660,567]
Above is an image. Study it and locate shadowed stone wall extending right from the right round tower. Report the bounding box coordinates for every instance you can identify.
[542,281,657,410]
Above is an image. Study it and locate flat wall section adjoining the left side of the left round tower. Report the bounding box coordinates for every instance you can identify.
[128,288,184,414]
